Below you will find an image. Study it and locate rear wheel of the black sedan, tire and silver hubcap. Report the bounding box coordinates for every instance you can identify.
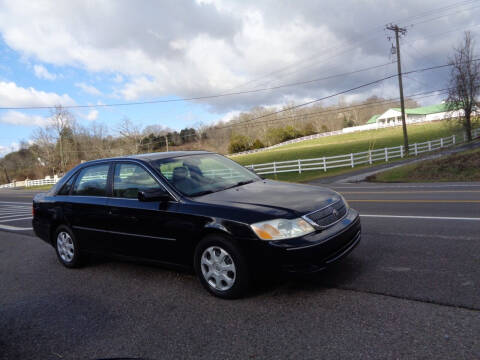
[53,225,82,268]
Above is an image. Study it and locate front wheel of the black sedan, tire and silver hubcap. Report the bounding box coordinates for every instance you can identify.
[194,234,249,299]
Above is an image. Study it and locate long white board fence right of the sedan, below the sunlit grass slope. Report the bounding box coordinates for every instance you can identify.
[246,128,480,175]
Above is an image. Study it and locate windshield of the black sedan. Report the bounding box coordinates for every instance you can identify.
[153,154,260,196]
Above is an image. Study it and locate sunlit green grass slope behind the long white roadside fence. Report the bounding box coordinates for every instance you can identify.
[231,120,463,166]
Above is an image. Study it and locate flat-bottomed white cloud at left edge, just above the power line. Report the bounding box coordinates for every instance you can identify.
[0,81,75,107]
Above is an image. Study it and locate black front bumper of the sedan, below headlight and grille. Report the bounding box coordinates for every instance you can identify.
[248,209,361,273]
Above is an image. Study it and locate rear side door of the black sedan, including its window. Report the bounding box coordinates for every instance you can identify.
[63,162,110,251]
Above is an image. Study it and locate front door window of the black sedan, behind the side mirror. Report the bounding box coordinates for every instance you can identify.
[113,163,162,199]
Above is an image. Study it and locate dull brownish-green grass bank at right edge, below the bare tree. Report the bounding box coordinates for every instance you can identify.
[368,143,480,182]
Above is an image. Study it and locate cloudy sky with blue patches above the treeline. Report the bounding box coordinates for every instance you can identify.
[0,0,480,156]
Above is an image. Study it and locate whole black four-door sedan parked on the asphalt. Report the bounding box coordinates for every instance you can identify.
[33,151,360,298]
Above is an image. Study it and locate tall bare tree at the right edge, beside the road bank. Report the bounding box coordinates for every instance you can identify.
[447,31,480,141]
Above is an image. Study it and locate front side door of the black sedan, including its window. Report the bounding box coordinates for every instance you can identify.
[108,162,178,262]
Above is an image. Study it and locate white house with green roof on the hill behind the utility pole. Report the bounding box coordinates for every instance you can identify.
[367,103,463,127]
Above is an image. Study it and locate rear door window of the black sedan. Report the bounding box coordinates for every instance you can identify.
[72,164,109,196]
